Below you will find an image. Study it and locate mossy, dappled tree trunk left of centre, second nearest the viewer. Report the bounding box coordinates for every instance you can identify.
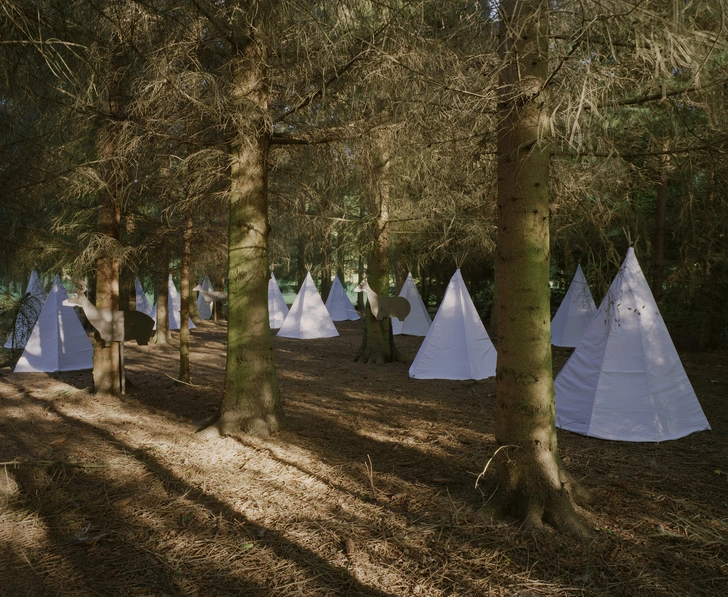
[210,28,285,436]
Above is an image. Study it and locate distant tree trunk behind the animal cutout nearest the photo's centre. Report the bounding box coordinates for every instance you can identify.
[355,127,401,363]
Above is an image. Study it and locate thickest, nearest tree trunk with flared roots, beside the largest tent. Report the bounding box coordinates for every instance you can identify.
[495,0,587,535]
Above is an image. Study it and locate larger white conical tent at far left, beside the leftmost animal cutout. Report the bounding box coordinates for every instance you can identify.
[14,276,94,373]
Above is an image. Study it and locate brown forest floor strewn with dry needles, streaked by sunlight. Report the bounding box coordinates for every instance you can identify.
[0,322,728,597]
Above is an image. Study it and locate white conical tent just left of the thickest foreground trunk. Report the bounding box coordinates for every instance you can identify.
[409,269,497,379]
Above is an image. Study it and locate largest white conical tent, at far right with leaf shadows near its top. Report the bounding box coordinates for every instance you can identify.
[554,248,710,442]
